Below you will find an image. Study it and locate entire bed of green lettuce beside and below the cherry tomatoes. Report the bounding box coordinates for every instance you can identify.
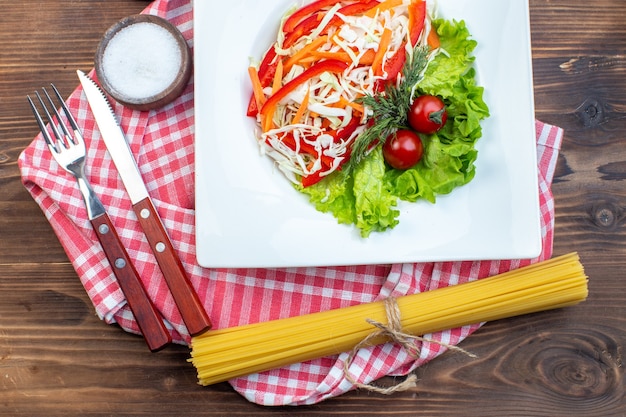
[296,19,489,237]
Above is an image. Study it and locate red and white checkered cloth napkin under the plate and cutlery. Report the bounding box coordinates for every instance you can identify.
[19,0,563,405]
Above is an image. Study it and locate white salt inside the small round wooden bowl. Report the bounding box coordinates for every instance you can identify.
[102,22,182,99]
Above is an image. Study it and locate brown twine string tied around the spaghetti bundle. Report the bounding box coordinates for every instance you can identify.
[343,297,477,395]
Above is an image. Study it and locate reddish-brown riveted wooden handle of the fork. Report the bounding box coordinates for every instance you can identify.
[91,213,172,352]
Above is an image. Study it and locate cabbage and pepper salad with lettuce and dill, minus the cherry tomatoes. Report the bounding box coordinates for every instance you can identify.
[247,0,489,237]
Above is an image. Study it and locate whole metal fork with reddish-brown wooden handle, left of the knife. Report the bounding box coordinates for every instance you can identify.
[27,84,172,352]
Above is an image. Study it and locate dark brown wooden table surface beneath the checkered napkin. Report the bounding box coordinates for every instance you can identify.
[0,0,626,416]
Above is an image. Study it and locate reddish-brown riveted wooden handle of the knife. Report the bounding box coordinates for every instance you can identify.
[133,197,211,336]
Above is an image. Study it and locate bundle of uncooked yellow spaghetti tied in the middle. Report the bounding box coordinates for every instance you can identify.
[190,253,588,385]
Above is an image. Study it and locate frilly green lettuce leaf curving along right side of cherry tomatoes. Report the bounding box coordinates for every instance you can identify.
[385,19,489,203]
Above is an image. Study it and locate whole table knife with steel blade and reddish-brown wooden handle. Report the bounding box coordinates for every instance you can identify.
[76,70,211,336]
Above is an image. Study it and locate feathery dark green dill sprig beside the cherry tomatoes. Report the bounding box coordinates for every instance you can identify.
[344,46,429,174]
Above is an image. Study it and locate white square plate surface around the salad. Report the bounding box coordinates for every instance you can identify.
[194,0,541,267]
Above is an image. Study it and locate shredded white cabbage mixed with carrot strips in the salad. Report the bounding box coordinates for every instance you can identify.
[252,0,436,183]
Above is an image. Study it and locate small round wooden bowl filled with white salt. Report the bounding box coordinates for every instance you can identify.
[95,14,192,110]
